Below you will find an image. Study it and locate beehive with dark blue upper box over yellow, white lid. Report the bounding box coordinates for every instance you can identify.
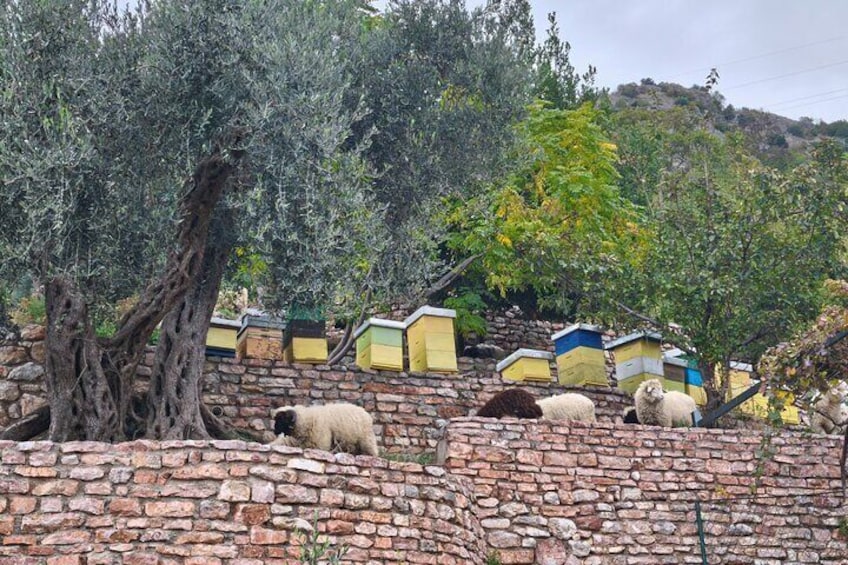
[551,324,609,386]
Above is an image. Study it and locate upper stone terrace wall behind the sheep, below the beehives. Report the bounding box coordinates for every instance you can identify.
[204,358,632,454]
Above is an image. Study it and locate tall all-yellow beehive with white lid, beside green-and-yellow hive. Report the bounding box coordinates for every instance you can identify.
[404,306,457,373]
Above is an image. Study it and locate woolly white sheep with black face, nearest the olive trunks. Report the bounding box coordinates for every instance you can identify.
[271,403,377,456]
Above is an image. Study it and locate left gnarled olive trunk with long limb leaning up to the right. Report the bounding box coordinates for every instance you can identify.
[45,153,234,442]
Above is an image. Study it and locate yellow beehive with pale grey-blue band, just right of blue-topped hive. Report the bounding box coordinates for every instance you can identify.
[607,332,663,394]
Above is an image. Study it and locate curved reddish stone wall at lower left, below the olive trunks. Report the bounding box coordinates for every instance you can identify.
[0,441,485,565]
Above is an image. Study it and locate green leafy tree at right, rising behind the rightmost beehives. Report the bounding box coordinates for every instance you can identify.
[609,107,846,406]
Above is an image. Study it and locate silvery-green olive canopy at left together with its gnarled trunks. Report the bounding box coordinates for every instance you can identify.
[0,0,540,440]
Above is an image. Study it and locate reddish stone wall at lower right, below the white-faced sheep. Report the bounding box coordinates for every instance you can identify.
[438,418,848,565]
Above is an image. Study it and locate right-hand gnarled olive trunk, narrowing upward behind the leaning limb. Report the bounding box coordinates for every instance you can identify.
[146,211,235,439]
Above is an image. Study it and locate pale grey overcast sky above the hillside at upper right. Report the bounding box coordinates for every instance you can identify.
[516,0,848,122]
